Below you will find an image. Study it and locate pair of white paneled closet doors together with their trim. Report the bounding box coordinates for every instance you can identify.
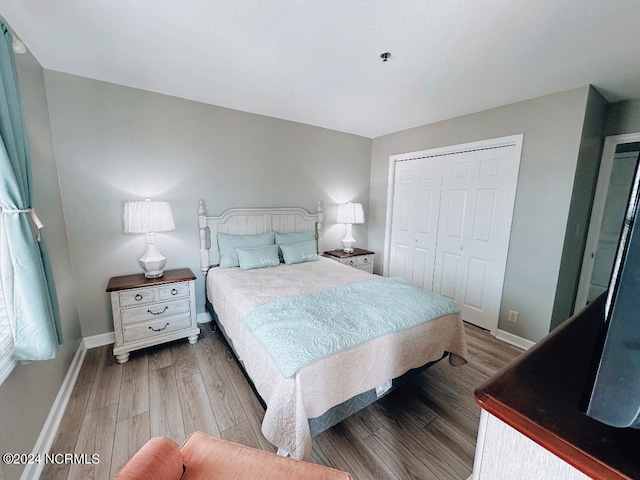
[384,135,522,334]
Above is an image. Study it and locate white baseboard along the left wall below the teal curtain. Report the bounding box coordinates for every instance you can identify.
[20,340,87,480]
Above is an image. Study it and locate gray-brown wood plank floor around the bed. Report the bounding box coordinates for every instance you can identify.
[42,324,521,480]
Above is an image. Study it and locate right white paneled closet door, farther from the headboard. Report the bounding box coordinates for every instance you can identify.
[433,145,519,332]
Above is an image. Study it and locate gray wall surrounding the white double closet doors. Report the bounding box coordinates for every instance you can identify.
[368,87,590,341]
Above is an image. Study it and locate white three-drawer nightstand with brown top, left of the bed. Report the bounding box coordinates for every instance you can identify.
[107,268,200,363]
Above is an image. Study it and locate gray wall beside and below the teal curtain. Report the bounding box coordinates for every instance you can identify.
[0,47,81,479]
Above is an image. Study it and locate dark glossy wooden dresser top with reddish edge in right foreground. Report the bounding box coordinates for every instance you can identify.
[474,296,640,479]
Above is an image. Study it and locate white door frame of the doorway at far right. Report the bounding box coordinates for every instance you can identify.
[573,132,640,312]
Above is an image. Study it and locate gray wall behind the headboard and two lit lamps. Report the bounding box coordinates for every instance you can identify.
[45,71,371,337]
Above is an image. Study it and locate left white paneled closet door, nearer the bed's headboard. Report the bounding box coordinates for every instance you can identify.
[389,157,442,290]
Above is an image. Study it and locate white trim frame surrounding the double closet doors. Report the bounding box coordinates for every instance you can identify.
[382,133,524,335]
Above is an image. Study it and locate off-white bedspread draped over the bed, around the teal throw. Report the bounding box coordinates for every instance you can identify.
[207,258,466,458]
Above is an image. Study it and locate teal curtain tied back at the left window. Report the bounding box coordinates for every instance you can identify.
[0,21,62,362]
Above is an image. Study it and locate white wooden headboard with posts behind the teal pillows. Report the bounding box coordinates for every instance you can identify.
[198,200,322,273]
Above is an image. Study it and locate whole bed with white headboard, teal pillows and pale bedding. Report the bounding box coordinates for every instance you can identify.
[198,201,466,458]
